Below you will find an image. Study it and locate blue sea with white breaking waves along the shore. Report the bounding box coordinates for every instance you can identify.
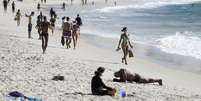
[46,0,201,73]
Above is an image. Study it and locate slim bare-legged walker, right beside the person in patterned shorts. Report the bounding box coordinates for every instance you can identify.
[72,21,79,49]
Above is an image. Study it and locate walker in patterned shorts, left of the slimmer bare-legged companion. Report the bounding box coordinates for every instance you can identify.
[63,17,72,49]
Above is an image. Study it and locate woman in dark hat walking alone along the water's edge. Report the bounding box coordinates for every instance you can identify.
[117,27,133,65]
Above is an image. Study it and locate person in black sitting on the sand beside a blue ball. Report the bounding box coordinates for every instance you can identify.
[91,67,116,96]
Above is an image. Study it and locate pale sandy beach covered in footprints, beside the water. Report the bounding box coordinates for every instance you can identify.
[0,0,201,101]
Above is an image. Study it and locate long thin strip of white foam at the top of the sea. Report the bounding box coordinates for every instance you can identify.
[96,0,199,13]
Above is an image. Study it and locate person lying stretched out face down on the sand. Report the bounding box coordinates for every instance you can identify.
[113,69,163,86]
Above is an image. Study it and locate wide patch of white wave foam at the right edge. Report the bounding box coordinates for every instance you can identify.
[157,32,201,60]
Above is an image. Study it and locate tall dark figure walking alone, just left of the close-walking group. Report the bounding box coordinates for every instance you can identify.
[41,16,51,54]
